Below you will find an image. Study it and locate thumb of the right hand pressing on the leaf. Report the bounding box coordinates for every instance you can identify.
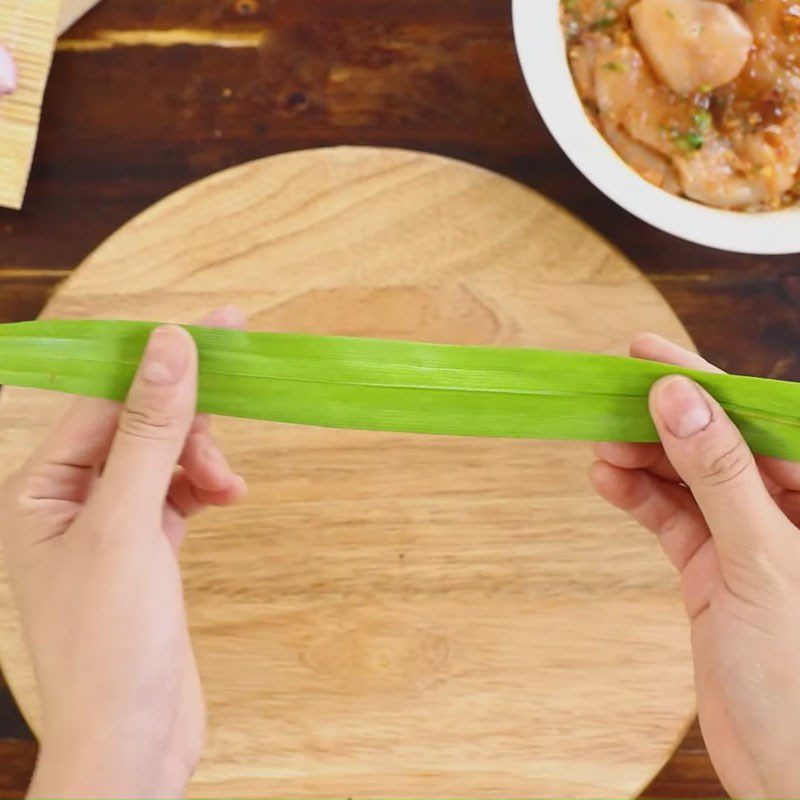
[650,375,790,566]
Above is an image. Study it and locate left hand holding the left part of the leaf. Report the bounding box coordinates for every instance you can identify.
[0,309,246,798]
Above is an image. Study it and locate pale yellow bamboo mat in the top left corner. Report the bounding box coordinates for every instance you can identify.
[0,0,61,208]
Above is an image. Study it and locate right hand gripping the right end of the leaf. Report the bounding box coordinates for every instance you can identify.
[591,335,800,798]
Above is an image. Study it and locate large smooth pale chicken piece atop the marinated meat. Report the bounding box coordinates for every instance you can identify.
[629,0,760,94]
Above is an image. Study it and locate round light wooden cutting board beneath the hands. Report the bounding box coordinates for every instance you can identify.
[0,148,693,798]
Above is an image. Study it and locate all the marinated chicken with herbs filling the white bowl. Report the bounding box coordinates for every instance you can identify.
[563,0,800,211]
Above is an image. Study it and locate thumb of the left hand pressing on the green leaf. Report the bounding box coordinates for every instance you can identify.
[96,325,197,520]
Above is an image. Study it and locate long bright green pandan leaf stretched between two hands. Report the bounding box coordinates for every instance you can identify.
[0,321,800,460]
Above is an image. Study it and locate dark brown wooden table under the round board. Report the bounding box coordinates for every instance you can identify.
[0,0,800,798]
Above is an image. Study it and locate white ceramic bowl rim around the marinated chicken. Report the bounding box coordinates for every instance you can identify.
[513,0,800,255]
